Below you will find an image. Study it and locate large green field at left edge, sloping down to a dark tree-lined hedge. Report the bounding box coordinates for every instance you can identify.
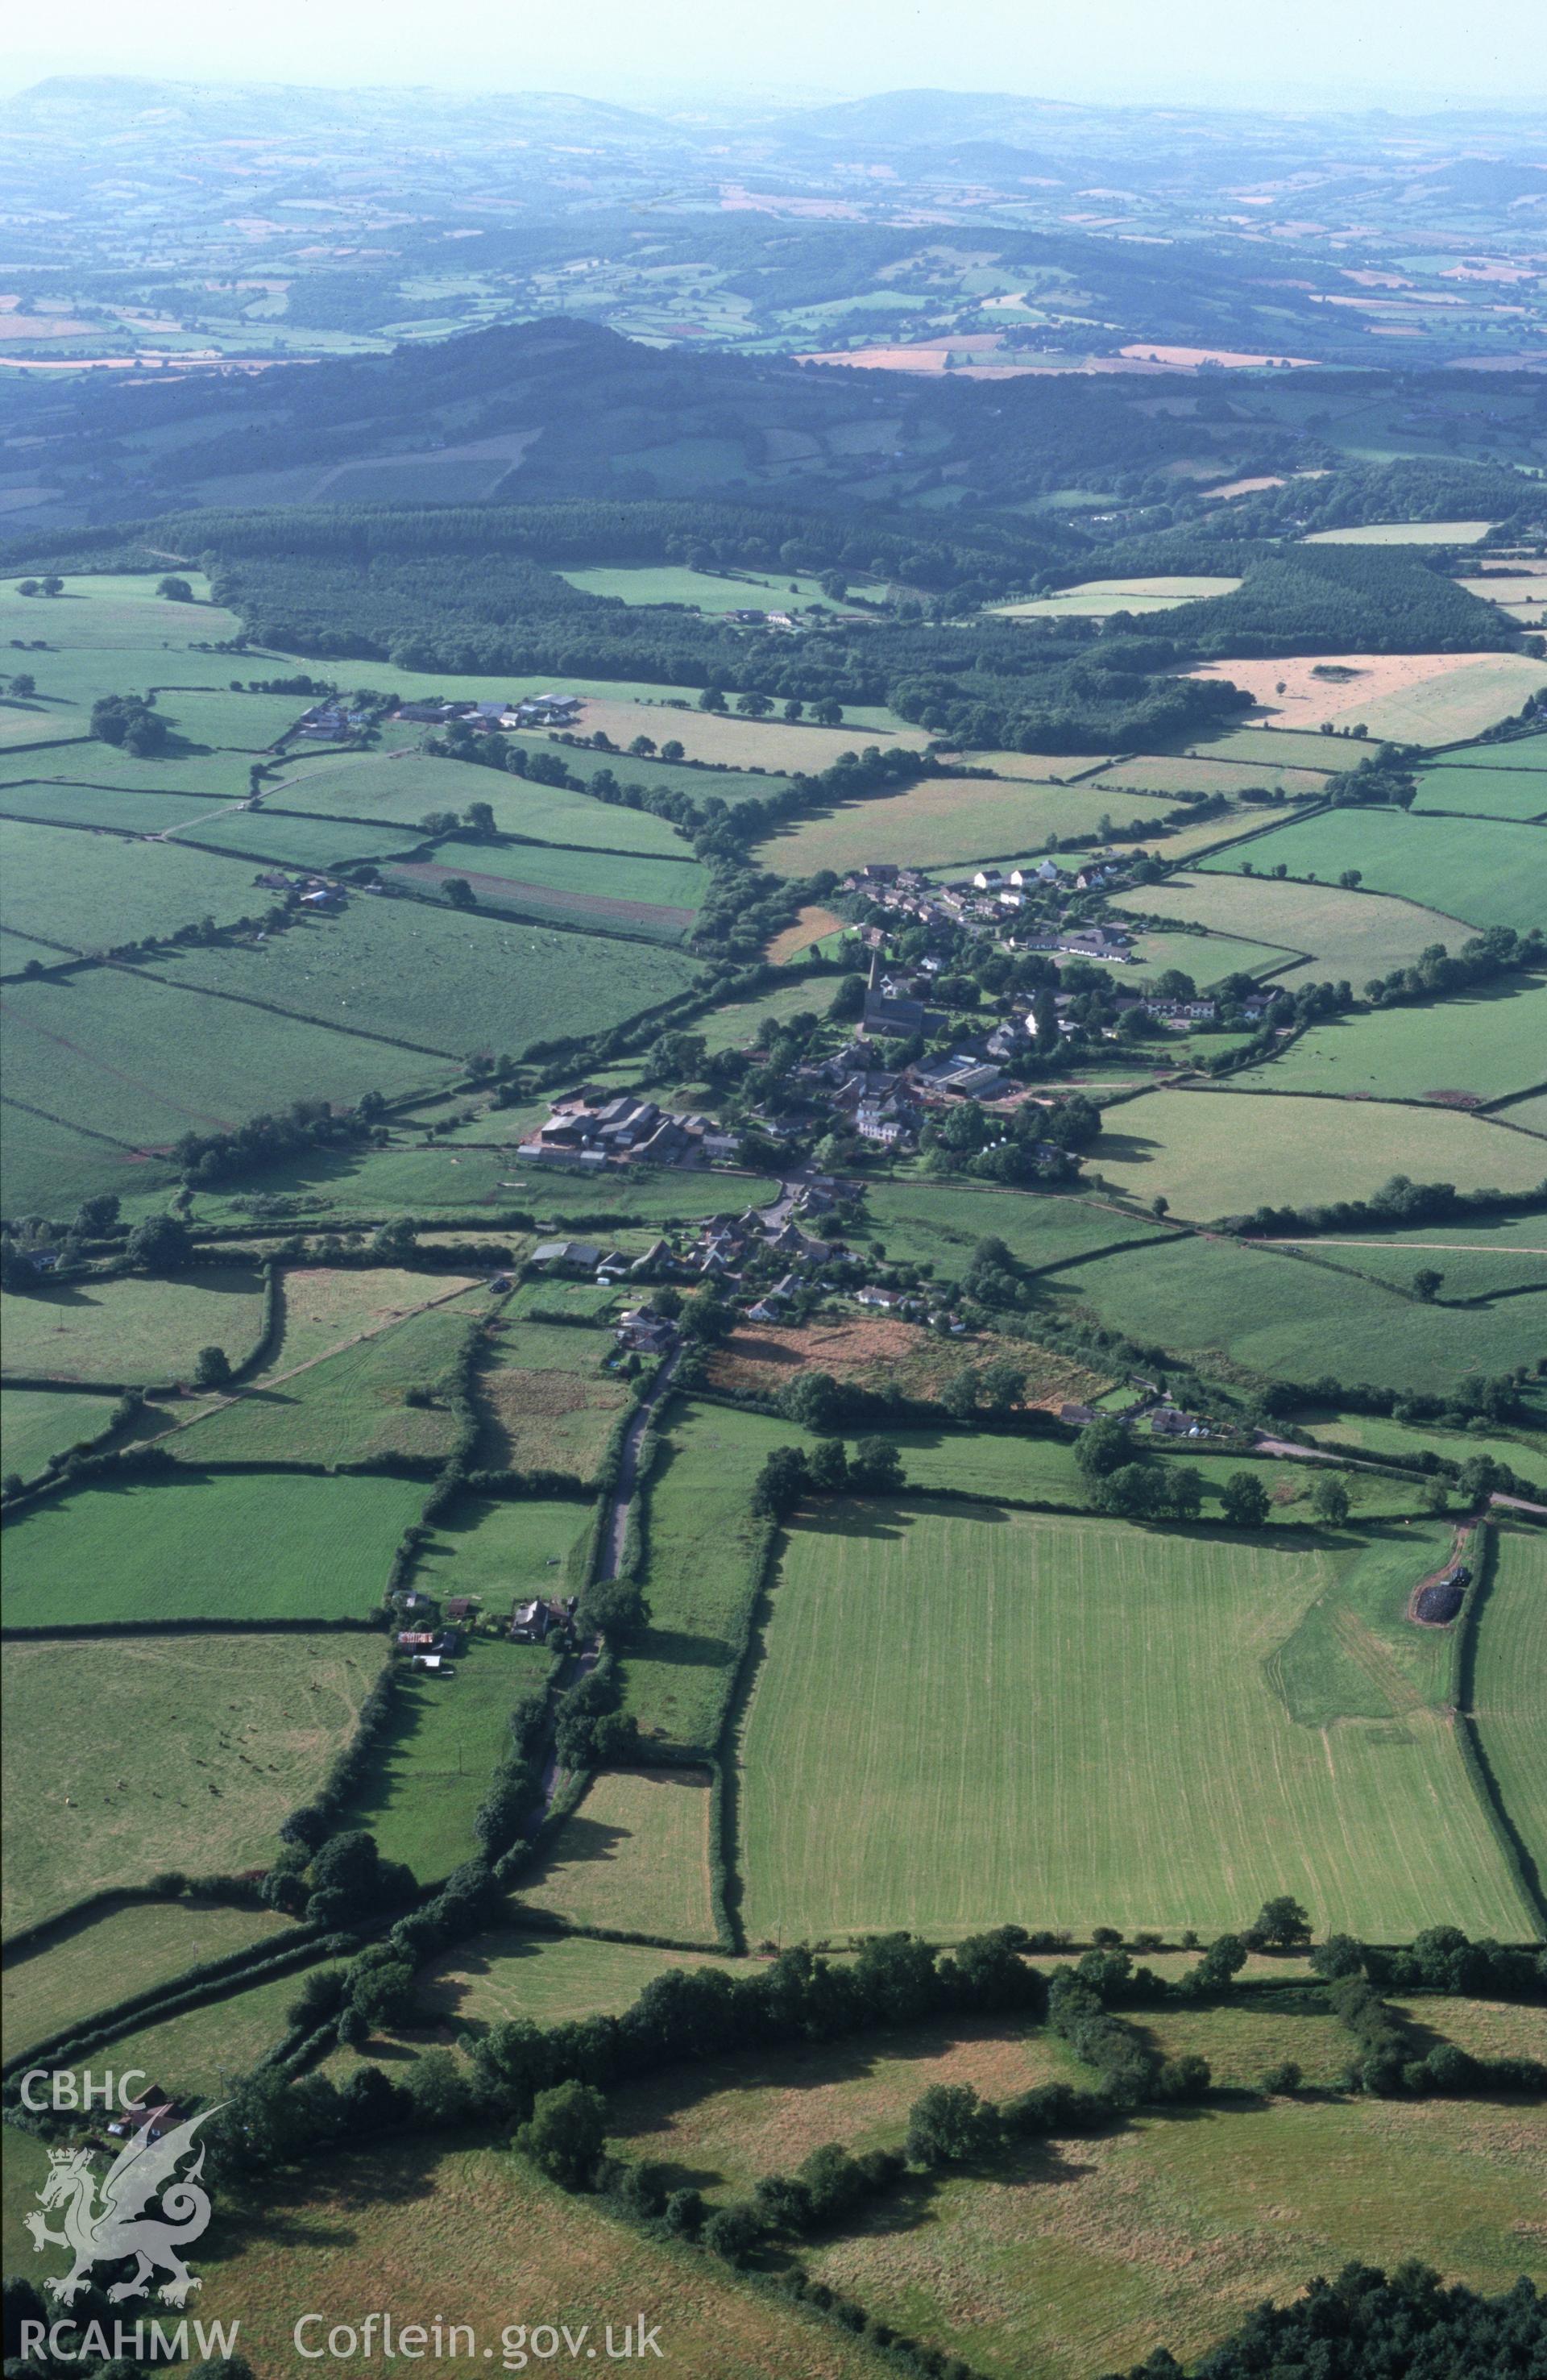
[0,962,445,1165]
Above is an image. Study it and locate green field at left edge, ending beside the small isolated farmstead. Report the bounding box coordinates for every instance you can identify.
[0,819,264,952]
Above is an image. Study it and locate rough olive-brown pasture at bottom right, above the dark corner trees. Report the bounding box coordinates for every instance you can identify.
[809,2094,1547,2380]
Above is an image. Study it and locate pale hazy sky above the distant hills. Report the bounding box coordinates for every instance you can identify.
[0,0,1547,110]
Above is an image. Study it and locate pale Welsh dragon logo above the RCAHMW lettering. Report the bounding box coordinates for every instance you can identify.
[26,2106,214,2306]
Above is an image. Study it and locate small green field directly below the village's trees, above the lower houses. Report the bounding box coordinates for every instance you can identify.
[854,1175,1168,1278]
